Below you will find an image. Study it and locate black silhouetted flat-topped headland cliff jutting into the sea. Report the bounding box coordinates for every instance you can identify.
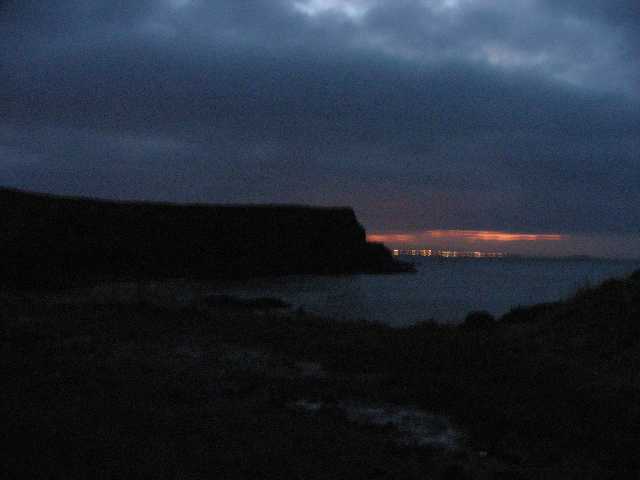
[0,189,410,283]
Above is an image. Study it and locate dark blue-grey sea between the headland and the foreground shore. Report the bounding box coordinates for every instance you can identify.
[210,256,640,327]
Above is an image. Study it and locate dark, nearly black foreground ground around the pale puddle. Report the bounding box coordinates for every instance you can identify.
[0,272,640,479]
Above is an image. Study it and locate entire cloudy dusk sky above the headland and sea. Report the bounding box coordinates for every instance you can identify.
[0,0,640,258]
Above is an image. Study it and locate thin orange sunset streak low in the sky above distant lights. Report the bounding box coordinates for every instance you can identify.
[367,230,568,244]
